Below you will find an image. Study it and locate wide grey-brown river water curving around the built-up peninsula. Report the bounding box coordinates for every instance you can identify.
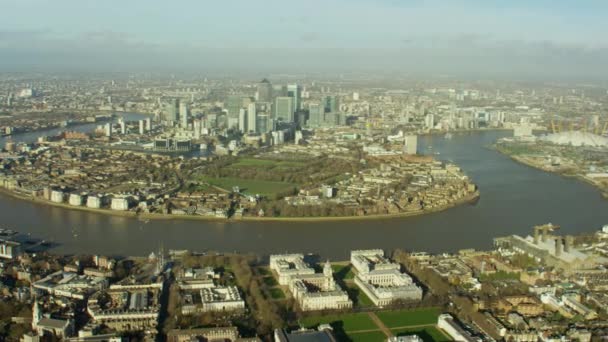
[0,119,608,260]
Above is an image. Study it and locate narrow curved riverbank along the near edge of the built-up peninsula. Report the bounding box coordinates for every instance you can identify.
[0,188,480,222]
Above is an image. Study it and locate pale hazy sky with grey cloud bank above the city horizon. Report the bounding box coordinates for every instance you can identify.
[0,0,608,78]
